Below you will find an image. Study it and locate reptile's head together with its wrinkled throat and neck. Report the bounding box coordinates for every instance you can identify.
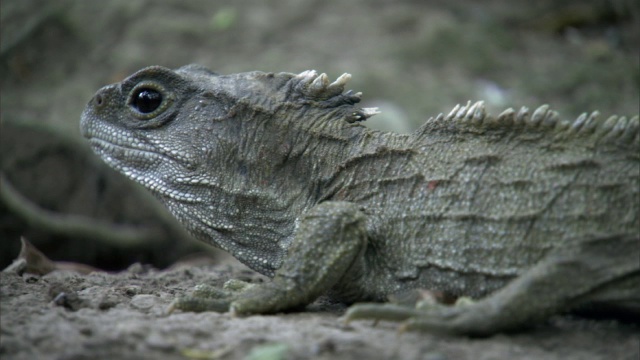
[80,65,376,273]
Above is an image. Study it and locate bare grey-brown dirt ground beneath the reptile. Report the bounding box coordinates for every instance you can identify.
[0,265,640,360]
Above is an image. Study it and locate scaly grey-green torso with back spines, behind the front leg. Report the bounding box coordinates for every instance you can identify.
[334,103,640,296]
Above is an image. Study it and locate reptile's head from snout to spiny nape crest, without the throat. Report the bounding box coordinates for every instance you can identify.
[80,65,377,176]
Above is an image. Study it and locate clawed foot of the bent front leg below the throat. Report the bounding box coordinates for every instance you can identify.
[167,279,255,314]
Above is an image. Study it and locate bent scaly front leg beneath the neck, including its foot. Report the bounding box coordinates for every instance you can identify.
[172,201,366,314]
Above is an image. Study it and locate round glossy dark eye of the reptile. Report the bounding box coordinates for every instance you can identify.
[127,81,174,120]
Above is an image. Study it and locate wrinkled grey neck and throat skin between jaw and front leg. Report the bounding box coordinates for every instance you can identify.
[159,83,384,276]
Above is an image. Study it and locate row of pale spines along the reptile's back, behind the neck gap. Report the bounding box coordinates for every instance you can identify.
[436,101,640,144]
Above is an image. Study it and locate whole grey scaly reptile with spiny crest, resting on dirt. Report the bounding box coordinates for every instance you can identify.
[81,65,640,335]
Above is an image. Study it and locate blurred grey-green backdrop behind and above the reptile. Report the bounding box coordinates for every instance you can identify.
[0,0,640,270]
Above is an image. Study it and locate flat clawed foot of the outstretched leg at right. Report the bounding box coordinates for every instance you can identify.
[344,298,495,336]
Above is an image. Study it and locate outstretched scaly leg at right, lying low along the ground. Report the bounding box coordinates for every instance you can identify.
[346,235,640,336]
